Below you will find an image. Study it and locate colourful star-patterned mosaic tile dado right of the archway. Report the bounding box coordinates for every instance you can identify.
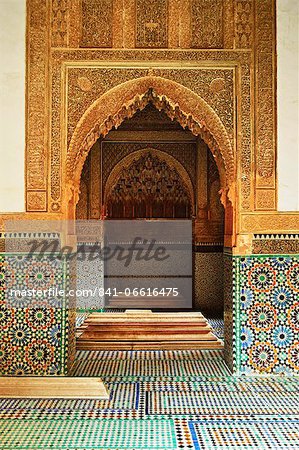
[234,255,299,374]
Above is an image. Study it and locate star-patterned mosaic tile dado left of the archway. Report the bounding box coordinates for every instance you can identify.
[0,253,75,375]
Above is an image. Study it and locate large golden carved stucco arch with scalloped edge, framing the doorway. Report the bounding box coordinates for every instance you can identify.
[66,76,236,218]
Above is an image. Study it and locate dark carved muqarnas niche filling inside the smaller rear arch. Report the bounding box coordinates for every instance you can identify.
[107,152,191,218]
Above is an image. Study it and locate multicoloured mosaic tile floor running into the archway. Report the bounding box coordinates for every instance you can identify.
[0,351,299,450]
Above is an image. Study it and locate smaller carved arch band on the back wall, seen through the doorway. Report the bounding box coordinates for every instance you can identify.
[104,147,195,214]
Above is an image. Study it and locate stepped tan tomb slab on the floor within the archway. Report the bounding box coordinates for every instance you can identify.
[77,310,223,350]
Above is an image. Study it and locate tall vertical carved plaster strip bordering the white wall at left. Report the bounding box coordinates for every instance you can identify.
[26,0,49,211]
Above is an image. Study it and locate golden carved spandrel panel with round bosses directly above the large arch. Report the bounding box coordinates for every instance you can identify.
[67,63,234,144]
